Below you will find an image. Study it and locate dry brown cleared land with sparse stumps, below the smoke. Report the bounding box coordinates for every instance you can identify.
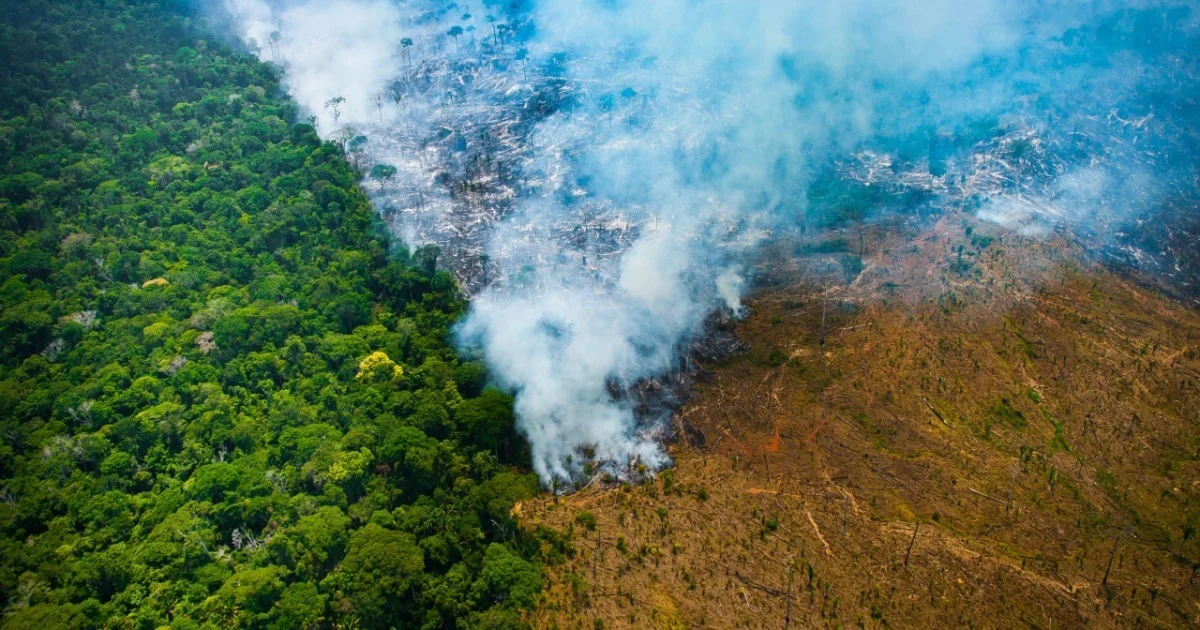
[518,215,1200,629]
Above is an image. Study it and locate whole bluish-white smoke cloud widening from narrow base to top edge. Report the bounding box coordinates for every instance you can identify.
[226,0,1196,482]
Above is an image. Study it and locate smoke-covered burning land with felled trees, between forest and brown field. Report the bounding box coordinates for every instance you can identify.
[223,2,1200,487]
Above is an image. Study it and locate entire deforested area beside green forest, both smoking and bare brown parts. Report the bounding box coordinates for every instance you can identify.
[216,0,1200,628]
